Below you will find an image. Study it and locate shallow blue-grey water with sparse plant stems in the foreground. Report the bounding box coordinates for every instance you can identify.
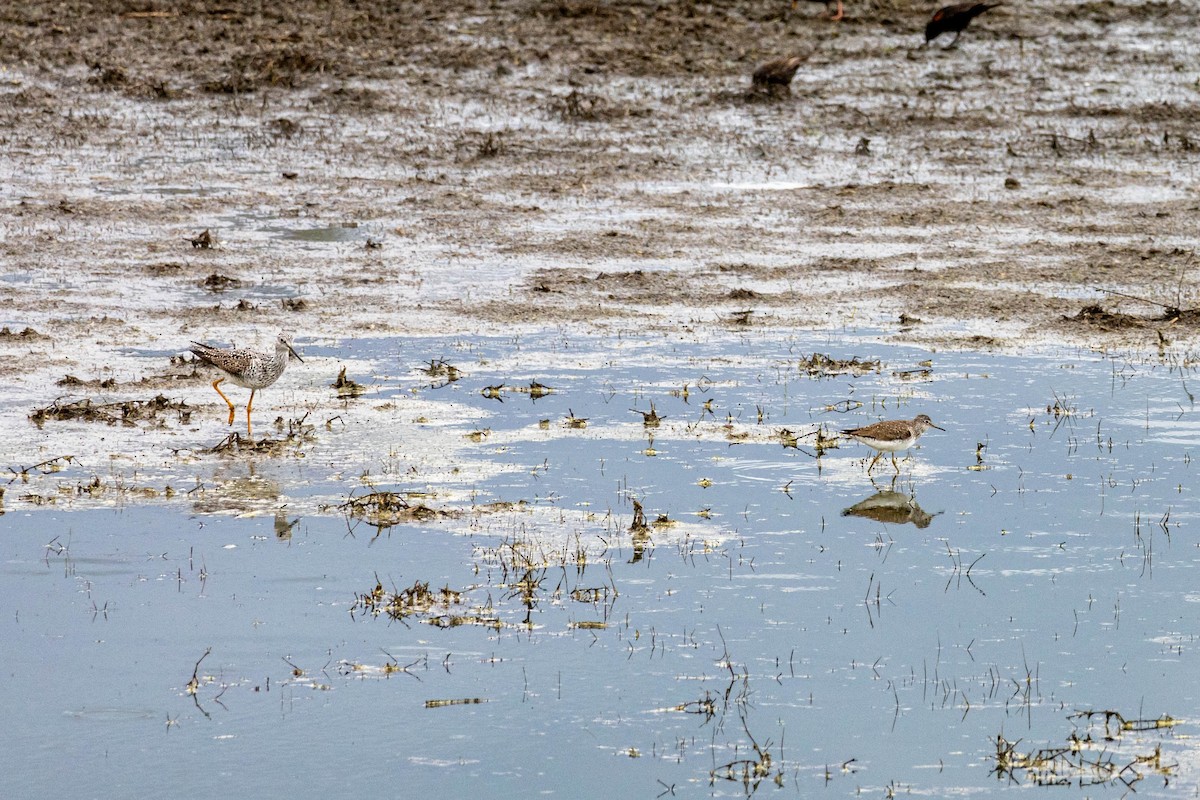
[0,329,1200,798]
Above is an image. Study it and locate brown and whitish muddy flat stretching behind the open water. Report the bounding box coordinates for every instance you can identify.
[0,0,1200,494]
